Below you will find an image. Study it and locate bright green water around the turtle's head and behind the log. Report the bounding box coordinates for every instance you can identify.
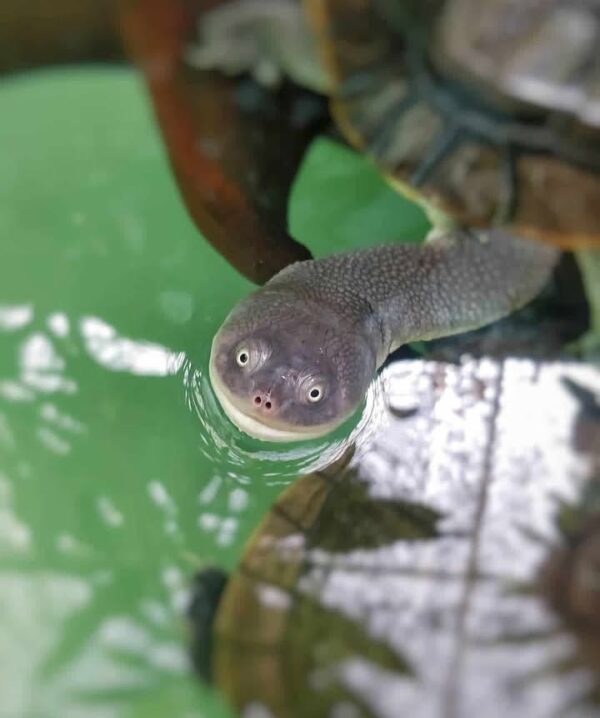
[0,69,426,718]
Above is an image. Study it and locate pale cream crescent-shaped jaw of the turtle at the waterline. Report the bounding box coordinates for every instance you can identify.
[208,356,339,442]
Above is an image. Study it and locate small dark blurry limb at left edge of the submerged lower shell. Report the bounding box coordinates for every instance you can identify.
[187,568,227,683]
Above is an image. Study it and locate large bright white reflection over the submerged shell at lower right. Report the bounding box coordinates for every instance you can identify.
[290,359,600,718]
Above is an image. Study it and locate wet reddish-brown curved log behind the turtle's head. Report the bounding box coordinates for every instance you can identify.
[120,0,322,283]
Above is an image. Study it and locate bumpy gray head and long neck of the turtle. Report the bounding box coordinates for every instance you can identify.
[210,230,559,441]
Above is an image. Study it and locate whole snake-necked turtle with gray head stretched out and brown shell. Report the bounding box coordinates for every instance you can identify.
[191,0,600,441]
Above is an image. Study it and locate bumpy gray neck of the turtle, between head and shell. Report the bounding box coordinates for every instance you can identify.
[267,230,559,361]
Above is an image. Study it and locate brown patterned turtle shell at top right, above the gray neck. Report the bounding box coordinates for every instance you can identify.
[305,0,600,248]
